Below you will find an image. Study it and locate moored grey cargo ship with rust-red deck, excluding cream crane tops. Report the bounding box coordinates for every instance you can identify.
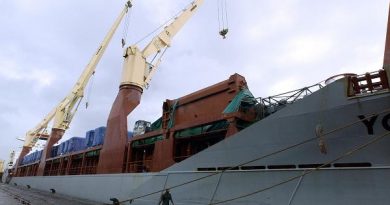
[4,2,390,205]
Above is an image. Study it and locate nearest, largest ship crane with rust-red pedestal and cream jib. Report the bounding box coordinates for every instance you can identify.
[97,0,203,174]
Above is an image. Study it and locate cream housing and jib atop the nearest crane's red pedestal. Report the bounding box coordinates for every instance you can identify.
[121,0,203,88]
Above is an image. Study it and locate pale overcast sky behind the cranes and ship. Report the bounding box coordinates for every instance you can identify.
[0,0,389,163]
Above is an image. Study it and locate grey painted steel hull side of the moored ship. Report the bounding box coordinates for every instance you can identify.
[11,79,390,205]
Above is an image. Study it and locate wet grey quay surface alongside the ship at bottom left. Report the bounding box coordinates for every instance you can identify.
[0,183,104,205]
